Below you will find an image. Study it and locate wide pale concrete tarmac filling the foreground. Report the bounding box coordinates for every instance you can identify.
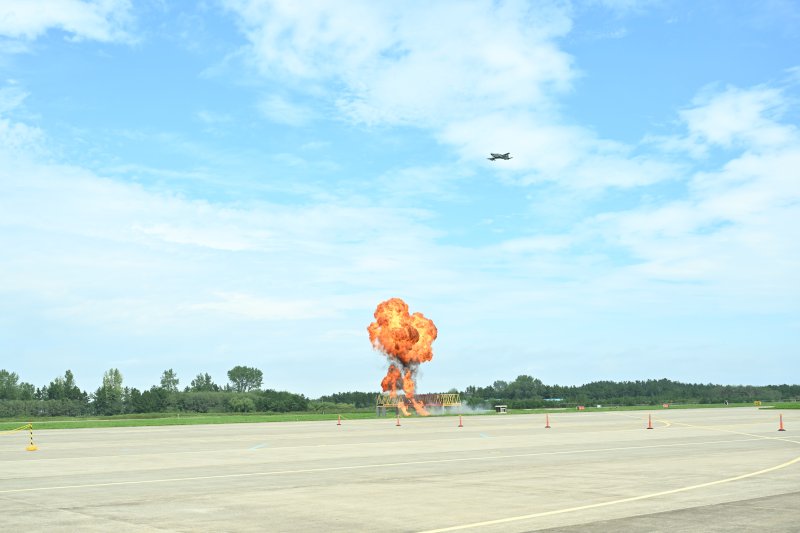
[0,408,800,533]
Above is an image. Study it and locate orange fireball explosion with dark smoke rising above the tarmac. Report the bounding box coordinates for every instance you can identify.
[367,298,437,416]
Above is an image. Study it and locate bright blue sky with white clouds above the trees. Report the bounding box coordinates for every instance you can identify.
[0,0,800,397]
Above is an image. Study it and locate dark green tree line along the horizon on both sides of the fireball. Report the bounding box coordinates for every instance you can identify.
[0,366,800,418]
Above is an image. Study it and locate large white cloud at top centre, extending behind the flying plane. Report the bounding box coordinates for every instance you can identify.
[227,0,688,189]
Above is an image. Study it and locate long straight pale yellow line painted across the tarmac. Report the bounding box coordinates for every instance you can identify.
[0,438,761,494]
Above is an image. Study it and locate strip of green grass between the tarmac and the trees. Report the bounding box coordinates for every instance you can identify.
[0,402,800,432]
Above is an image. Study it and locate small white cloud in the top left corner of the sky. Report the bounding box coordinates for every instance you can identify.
[0,0,131,42]
